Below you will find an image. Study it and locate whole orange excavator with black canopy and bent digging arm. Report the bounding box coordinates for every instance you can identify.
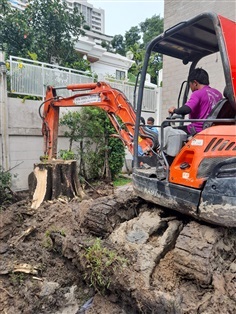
[43,13,236,227]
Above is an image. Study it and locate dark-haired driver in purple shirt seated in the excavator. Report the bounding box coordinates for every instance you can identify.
[168,68,223,135]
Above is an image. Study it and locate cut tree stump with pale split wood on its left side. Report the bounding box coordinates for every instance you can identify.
[28,159,85,209]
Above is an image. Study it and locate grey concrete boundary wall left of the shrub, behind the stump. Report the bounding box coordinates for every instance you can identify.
[0,98,68,190]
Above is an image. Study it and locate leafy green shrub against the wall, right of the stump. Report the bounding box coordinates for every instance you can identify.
[60,107,125,181]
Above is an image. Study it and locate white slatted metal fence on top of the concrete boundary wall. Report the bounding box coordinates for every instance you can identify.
[8,56,158,112]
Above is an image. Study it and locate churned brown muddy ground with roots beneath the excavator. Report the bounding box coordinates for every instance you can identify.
[0,184,236,314]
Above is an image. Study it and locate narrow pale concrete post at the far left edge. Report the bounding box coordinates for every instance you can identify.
[0,51,9,171]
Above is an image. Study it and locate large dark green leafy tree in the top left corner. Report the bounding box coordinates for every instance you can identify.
[0,0,84,64]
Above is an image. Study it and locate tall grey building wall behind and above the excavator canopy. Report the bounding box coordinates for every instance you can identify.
[161,0,236,119]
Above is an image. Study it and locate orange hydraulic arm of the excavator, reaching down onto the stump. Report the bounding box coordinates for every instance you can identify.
[40,82,155,160]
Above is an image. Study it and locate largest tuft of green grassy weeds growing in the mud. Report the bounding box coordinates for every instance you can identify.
[84,238,127,293]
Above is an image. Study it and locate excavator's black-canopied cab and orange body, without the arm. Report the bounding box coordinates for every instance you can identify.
[133,13,236,227]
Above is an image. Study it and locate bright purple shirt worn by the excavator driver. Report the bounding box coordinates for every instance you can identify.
[185,85,223,133]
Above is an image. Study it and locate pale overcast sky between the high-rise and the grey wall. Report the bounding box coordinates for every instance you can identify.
[88,0,164,36]
